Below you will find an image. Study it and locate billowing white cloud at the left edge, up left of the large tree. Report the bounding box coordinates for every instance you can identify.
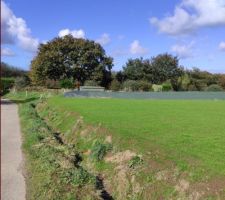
[1,1,39,52]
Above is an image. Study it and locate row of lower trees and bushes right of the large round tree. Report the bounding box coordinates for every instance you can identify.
[111,56,225,91]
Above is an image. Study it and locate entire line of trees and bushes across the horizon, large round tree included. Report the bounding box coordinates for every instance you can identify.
[1,35,225,91]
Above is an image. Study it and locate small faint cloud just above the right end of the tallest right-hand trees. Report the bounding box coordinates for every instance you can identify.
[171,42,194,59]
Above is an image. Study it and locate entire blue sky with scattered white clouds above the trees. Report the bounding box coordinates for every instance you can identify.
[1,0,225,73]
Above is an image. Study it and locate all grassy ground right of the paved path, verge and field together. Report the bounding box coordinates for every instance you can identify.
[5,93,225,200]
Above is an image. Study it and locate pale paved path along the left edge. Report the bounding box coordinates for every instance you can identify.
[1,100,26,200]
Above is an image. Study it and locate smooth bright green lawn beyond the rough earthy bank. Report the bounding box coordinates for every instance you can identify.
[48,96,225,176]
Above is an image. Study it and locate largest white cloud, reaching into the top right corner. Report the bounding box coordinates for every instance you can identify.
[150,0,225,35]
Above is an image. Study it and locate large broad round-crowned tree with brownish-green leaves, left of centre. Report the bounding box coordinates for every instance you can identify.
[31,35,113,86]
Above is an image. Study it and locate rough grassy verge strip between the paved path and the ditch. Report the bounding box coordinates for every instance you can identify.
[14,94,107,200]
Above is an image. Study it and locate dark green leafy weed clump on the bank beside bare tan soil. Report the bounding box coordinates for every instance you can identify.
[90,140,112,161]
